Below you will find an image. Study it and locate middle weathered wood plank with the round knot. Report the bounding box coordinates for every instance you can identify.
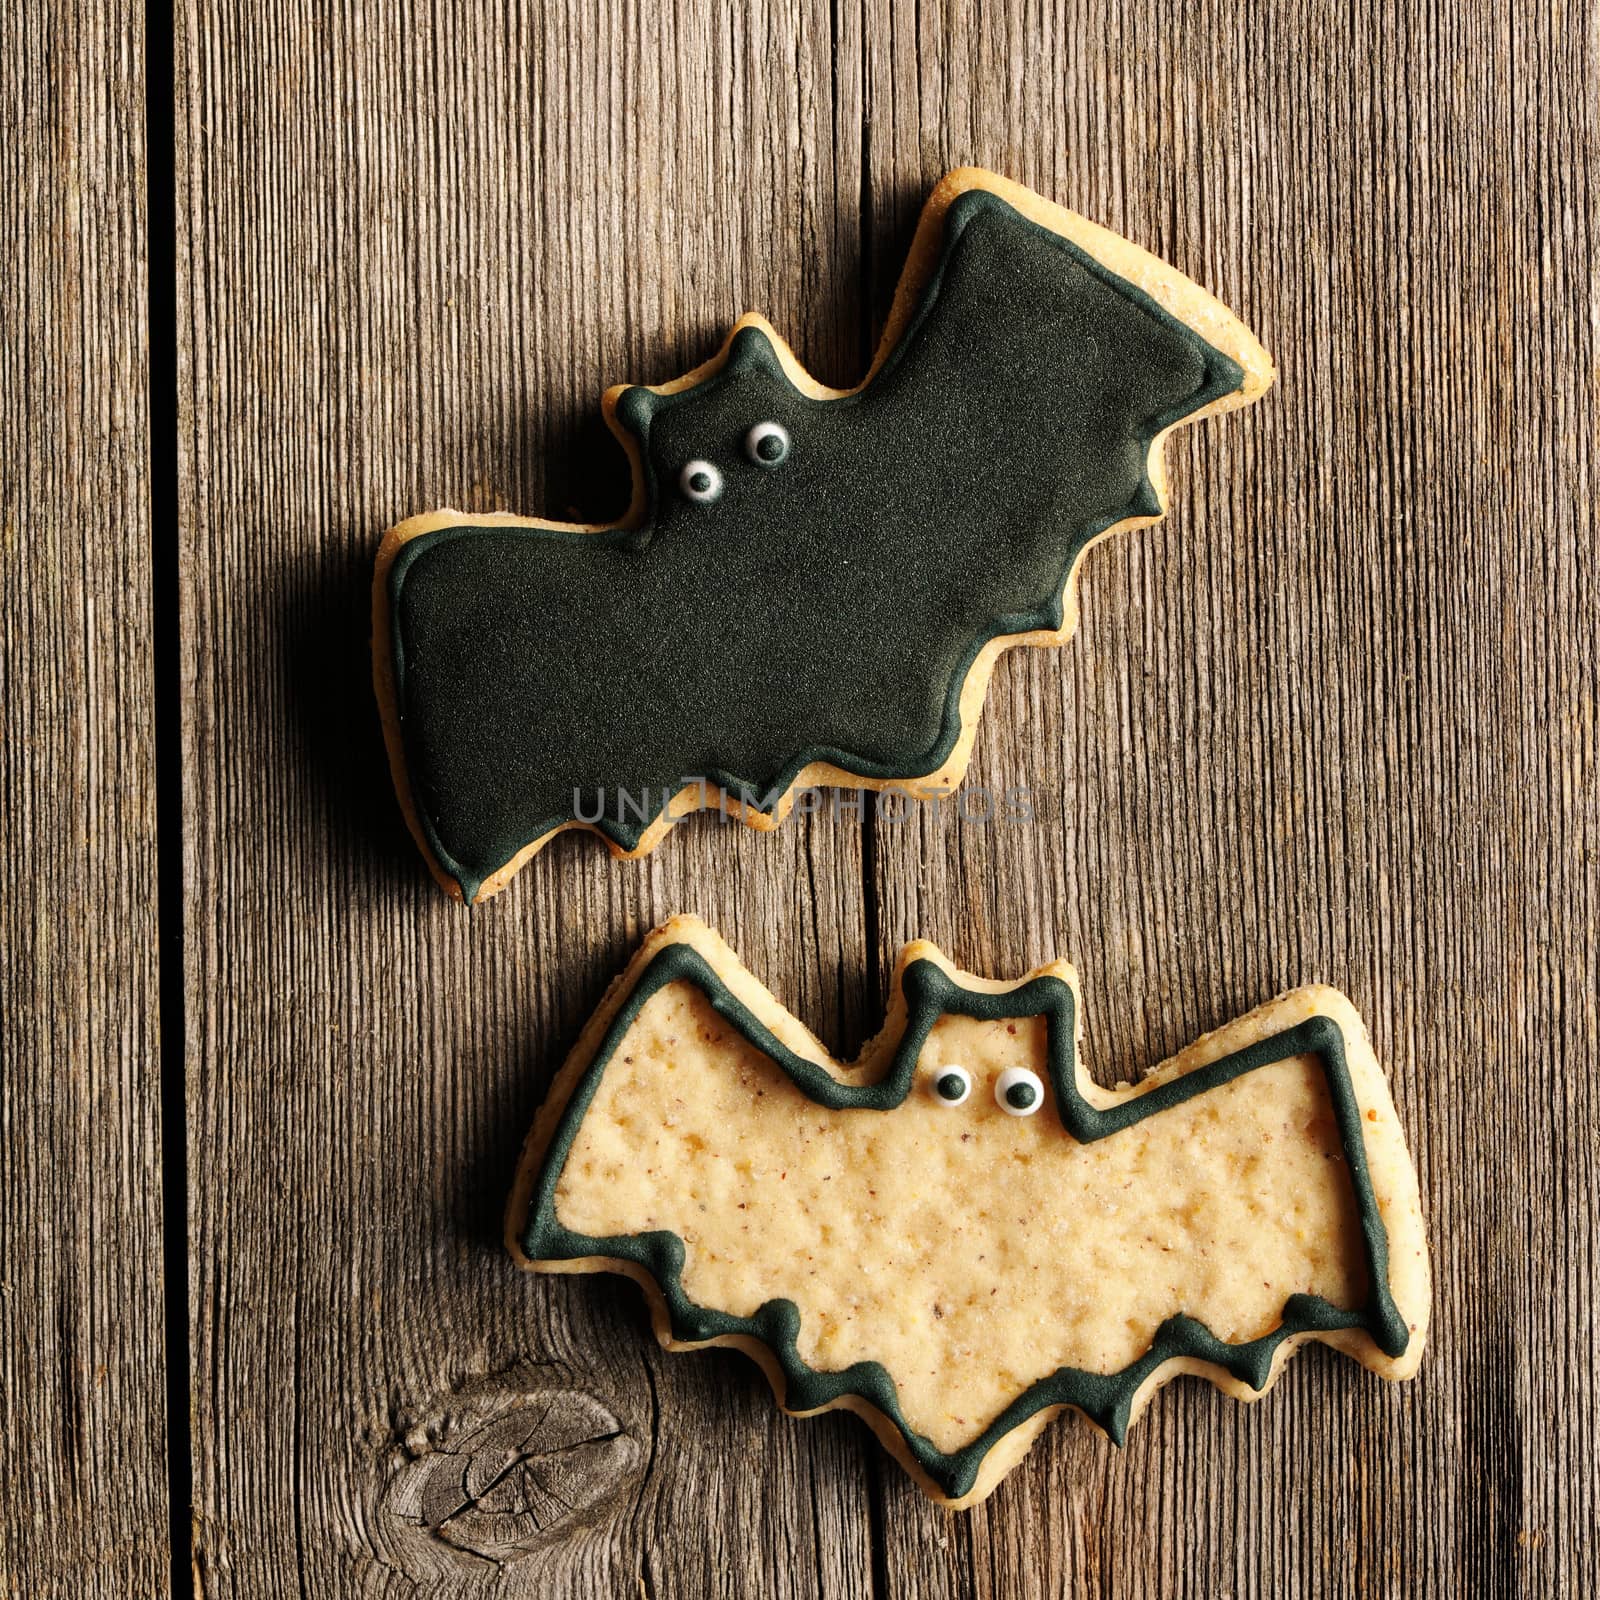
[178,0,875,1600]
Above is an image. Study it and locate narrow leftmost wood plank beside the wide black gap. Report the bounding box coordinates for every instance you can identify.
[0,3,168,1600]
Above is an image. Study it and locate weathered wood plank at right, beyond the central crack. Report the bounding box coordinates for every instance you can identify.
[866,3,1600,1597]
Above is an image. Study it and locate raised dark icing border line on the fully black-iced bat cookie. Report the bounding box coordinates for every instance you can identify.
[389,187,1246,904]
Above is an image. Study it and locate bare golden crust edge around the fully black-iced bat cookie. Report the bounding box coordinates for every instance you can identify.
[371,166,1275,906]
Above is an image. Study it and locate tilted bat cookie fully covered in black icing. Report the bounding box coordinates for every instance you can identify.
[374,170,1272,901]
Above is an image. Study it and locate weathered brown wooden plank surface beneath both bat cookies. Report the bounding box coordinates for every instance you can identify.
[0,0,1600,1600]
